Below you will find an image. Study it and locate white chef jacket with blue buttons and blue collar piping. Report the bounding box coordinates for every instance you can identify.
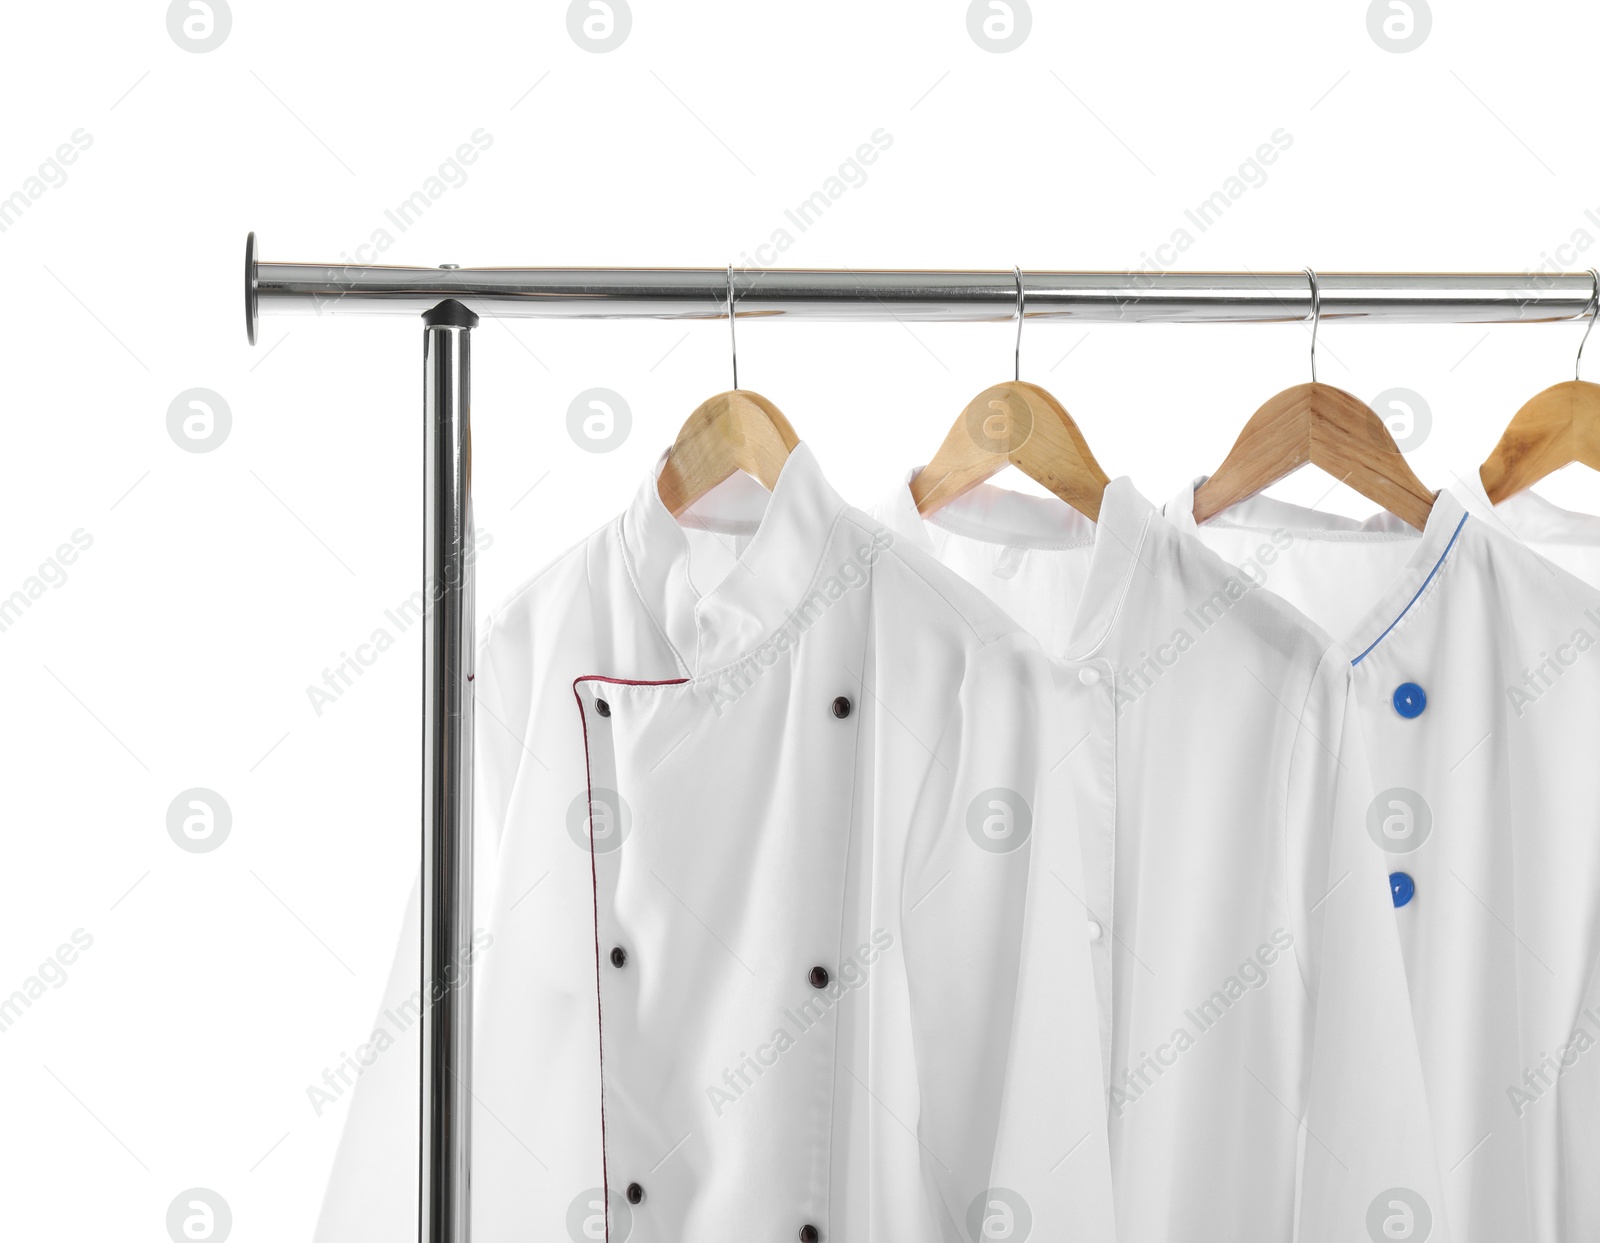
[1166,476,1600,1243]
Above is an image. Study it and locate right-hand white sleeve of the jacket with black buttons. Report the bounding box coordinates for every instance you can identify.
[901,637,1114,1243]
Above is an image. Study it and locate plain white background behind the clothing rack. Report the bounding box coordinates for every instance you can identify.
[0,0,1600,1243]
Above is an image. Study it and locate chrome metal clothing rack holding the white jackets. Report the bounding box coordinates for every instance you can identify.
[245,234,1597,1243]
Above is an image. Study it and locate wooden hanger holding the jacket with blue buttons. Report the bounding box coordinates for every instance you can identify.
[1195,269,1435,531]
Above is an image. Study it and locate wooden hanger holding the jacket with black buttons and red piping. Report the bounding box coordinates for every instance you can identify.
[656,264,800,518]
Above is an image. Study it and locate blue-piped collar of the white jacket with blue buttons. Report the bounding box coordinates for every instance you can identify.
[1162,477,1467,664]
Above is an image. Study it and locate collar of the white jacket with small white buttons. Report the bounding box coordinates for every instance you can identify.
[877,469,1155,661]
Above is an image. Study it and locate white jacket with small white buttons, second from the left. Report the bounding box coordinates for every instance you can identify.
[877,478,1443,1243]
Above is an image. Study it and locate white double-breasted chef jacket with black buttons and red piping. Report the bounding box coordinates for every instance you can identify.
[312,445,1112,1243]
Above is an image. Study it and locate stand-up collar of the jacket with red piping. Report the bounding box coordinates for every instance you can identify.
[618,443,845,677]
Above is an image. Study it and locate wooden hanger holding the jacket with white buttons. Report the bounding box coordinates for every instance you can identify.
[910,269,1110,522]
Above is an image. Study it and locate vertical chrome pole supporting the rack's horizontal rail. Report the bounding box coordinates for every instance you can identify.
[418,299,478,1243]
